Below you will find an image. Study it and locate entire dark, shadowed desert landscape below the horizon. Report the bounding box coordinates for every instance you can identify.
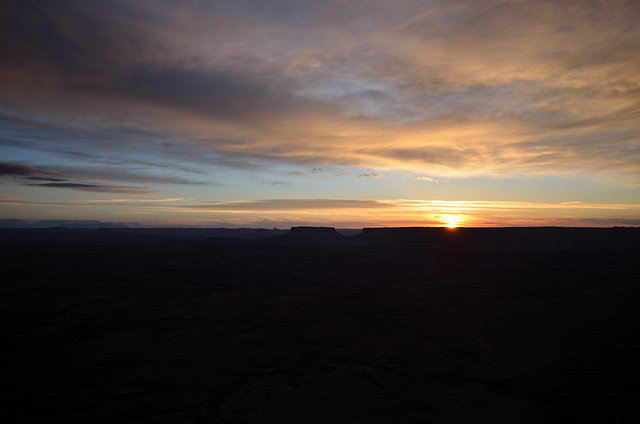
[0,227,640,424]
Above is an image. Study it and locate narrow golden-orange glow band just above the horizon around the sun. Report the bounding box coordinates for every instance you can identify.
[4,198,640,229]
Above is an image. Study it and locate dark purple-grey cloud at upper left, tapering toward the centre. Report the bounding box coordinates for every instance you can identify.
[0,1,312,125]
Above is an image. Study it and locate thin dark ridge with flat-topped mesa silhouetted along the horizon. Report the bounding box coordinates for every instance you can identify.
[0,226,640,250]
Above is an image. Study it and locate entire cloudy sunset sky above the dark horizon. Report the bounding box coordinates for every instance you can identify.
[0,0,640,228]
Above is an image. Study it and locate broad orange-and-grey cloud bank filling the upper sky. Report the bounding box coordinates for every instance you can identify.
[0,0,640,189]
